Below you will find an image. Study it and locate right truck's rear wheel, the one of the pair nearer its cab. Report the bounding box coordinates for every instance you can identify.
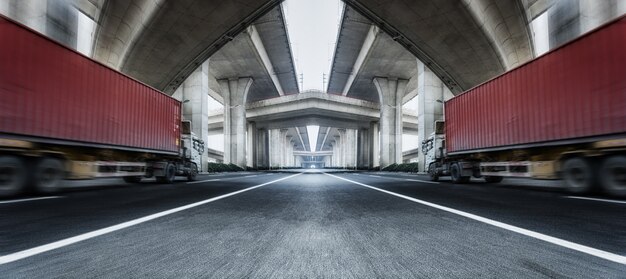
[562,158,595,194]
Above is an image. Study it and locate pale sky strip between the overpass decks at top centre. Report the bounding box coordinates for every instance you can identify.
[283,0,343,91]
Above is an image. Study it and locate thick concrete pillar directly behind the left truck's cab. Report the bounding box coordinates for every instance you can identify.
[177,60,209,171]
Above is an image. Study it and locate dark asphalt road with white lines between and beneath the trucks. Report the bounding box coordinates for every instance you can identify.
[0,173,626,278]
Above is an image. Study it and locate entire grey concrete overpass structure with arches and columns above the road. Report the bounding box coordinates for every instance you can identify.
[0,0,626,171]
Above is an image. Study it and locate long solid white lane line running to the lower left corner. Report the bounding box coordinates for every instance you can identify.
[0,173,301,265]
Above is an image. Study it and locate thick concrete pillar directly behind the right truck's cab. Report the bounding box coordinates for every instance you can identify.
[417,60,453,171]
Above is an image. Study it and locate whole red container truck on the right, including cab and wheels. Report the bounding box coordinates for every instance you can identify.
[422,17,626,196]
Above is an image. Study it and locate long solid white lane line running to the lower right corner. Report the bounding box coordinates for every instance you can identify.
[325,173,626,265]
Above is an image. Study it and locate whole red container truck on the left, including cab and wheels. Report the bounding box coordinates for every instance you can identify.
[0,16,203,196]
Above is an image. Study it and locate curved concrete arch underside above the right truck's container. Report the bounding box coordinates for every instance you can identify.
[344,0,533,93]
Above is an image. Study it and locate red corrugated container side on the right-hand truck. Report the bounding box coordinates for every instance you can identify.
[445,17,626,154]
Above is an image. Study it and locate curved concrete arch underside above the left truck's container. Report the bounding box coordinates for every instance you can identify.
[94,0,282,93]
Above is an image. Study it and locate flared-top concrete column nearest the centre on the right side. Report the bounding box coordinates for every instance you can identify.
[374,77,407,168]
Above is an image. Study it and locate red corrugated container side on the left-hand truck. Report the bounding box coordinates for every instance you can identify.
[0,17,181,153]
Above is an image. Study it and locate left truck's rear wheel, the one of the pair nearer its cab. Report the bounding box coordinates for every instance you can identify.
[32,158,65,194]
